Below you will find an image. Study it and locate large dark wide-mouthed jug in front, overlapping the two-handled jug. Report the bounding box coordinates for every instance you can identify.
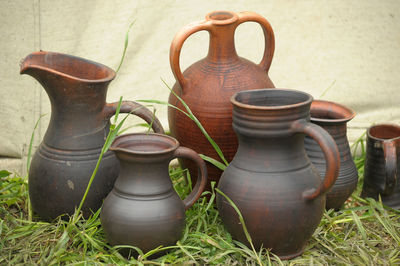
[217,89,340,259]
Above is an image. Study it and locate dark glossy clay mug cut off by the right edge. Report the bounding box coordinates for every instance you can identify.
[361,124,400,209]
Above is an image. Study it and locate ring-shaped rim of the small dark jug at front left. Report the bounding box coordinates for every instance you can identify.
[109,132,180,155]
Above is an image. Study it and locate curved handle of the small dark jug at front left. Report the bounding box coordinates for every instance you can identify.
[174,147,208,210]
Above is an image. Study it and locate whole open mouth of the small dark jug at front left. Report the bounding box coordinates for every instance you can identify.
[110,133,179,155]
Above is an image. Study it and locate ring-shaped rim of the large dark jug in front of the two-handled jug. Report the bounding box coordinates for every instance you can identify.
[230,88,313,110]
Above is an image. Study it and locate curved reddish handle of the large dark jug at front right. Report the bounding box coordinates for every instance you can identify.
[291,120,340,200]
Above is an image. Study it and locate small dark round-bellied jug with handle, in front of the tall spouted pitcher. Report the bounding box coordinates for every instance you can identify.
[100,134,207,253]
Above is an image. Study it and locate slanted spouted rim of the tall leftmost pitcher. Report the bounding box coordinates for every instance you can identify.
[20,51,116,83]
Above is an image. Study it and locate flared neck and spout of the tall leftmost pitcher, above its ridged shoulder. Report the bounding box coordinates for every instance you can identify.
[20,51,115,150]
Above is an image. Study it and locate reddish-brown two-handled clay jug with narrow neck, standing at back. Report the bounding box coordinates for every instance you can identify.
[168,11,275,189]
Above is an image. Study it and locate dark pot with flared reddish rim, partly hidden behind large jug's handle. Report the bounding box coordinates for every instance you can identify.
[304,100,358,210]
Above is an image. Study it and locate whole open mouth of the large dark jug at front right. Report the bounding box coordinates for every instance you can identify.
[231,89,313,110]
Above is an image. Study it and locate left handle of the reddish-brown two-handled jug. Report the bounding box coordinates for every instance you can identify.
[169,20,212,88]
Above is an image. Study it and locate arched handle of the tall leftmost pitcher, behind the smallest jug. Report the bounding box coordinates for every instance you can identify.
[105,101,164,134]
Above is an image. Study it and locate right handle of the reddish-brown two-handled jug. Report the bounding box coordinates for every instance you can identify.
[238,11,275,73]
